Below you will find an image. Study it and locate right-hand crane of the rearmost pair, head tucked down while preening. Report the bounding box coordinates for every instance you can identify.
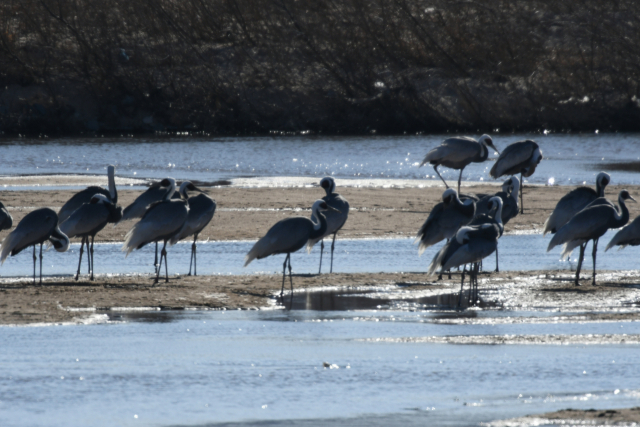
[489,139,542,214]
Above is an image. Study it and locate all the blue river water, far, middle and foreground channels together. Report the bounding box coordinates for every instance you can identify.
[0,134,640,427]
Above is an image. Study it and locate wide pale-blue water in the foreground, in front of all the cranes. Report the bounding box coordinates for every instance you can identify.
[0,311,640,427]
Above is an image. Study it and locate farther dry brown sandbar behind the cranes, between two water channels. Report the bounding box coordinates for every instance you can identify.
[5,181,640,242]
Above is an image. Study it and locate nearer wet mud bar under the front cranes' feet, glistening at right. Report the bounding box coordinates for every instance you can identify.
[0,271,640,328]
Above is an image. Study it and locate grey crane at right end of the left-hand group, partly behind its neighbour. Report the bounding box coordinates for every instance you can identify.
[178,181,216,276]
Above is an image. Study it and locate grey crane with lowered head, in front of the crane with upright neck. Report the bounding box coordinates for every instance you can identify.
[60,193,122,280]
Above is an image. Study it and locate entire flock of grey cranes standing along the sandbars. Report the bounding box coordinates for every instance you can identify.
[0,135,640,303]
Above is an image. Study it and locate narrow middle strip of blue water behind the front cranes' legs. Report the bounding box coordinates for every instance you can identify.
[0,231,640,277]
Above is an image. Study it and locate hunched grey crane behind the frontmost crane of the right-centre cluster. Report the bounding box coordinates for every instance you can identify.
[414,188,476,255]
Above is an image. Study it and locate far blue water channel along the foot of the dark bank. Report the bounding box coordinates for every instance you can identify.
[0,134,640,185]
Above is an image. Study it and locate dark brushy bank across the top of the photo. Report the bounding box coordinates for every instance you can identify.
[0,0,640,135]
